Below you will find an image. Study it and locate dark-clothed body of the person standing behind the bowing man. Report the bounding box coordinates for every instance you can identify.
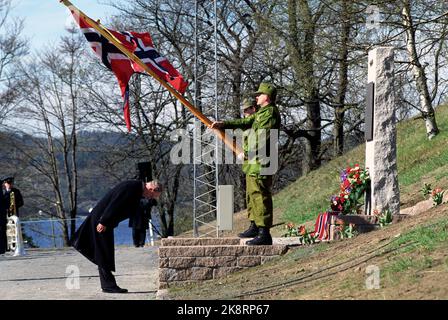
[129,198,157,247]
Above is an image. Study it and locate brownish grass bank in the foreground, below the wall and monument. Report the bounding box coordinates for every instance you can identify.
[169,204,448,300]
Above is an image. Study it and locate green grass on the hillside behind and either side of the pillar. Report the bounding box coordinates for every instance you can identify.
[274,106,448,224]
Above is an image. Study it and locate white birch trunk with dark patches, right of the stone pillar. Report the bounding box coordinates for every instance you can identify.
[402,1,439,140]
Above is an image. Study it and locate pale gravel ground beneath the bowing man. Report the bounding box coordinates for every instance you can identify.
[0,247,159,300]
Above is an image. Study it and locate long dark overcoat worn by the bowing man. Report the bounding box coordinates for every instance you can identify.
[73,180,143,271]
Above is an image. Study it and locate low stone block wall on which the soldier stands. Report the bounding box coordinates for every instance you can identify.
[159,238,288,289]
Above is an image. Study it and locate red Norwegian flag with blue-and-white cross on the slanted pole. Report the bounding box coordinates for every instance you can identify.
[71,10,188,131]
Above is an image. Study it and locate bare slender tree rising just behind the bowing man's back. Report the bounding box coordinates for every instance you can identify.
[14,31,84,245]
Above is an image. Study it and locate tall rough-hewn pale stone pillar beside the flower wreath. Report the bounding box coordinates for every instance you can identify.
[366,47,400,214]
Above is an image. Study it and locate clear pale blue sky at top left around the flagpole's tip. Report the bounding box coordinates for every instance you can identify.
[11,0,120,51]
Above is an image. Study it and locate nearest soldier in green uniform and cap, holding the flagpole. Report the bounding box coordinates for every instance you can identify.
[211,83,281,245]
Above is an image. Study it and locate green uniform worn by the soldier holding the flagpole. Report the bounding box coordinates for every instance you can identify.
[224,99,280,228]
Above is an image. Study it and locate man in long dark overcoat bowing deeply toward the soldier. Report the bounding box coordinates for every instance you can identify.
[73,180,162,293]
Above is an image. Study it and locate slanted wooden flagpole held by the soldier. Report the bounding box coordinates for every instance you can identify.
[59,0,243,157]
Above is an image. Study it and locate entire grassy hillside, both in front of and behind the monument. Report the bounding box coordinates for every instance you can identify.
[169,106,448,299]
